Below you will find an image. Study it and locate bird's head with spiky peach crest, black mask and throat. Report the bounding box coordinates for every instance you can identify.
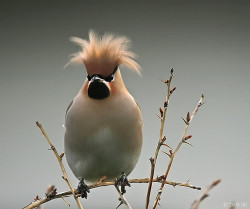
[66,31,140,99]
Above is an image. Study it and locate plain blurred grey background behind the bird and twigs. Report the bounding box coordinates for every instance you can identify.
[0,0,250,209]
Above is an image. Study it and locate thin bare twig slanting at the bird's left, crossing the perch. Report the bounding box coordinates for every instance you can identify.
[31,122,83,209]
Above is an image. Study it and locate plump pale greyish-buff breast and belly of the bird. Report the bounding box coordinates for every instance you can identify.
[64,91,142,182]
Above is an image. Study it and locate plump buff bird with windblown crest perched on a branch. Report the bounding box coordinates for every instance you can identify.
[64,30,143,198]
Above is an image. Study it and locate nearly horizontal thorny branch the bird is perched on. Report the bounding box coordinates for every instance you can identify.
[26,178,201,209]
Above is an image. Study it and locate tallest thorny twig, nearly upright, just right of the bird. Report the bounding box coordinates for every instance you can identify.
[145,68,174,209]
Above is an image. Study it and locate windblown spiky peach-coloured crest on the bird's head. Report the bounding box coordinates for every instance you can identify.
[69,31,140,76]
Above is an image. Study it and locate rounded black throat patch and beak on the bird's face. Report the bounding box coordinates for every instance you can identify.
[88,75,110,99]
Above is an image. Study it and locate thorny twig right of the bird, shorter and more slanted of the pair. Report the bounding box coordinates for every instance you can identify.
[153,94,204,209]
